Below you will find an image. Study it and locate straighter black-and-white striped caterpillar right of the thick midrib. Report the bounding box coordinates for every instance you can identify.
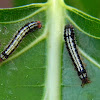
[64,25,90,86]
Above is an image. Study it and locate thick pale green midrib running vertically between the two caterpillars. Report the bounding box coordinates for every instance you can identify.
[46,0,64,100]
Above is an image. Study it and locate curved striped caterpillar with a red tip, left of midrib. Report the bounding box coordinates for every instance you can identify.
[0,21,41,62]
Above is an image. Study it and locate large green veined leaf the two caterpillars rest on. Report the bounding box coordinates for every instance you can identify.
[0,0,100,100]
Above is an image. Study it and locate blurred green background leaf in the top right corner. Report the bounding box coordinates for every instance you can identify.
[65,0,100,18]
